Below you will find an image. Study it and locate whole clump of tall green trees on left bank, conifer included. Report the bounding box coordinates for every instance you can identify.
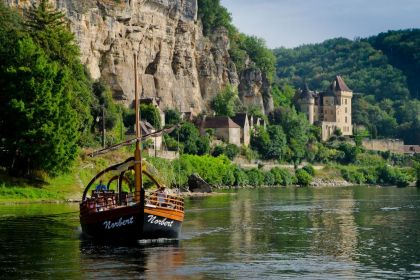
[0,1,93,175]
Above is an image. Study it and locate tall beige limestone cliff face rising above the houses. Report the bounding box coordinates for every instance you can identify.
[5,0,272,113]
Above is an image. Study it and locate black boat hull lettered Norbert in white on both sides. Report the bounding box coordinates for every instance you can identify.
[80,206,182,240]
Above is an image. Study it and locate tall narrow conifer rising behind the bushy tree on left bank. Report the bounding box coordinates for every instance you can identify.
[25,0,95,145]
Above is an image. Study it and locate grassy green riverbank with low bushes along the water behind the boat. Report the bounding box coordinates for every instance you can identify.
[0,149,415,203]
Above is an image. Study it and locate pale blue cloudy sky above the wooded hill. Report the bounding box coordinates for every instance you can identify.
[220,0,420,48]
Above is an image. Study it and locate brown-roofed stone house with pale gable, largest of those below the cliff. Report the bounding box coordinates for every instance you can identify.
[197,116,241,146]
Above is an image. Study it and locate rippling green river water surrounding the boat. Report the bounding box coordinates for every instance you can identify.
[0,187,420,279]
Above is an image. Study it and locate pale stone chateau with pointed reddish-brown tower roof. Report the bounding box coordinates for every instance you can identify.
[296,76,353,141]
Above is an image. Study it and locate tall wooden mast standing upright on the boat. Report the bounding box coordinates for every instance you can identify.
[134,53,143,202]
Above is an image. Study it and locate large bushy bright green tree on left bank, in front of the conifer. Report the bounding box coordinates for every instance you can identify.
[0,37,79,175]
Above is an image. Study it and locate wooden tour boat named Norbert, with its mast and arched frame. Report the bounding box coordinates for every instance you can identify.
[80,56,184,241]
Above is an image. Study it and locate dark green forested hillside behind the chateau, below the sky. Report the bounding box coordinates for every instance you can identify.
[274,30,420,144]
